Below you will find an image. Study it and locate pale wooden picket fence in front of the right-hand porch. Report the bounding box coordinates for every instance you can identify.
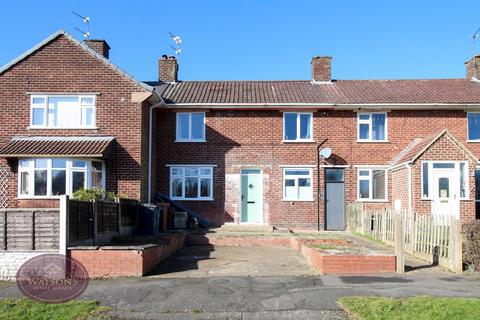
[347,203,462,272]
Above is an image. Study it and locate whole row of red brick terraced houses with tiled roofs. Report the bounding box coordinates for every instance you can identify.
[0,31,480,230]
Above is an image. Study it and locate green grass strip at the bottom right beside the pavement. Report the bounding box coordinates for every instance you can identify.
[339,296,480,320]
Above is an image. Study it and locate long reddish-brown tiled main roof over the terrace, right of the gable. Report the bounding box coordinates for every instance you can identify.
[147,79,480,104]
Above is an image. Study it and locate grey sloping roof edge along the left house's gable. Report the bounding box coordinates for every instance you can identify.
[0,30,154,92]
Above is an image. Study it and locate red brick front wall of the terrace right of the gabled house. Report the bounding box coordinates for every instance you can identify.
[154,110,480,229]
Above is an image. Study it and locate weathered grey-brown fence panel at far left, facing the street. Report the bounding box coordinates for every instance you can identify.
[0,209,60,250]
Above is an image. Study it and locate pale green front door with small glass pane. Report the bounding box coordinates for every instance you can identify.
[242,169,263,223]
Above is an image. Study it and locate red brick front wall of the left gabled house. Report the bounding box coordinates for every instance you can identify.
[0,35,148,207]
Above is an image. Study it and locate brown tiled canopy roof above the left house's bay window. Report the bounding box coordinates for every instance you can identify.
[0,137,114,158]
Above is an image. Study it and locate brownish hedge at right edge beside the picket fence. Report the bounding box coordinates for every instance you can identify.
[463,221,480,271]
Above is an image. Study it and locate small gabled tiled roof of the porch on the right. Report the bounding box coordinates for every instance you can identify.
[390,129,478,167]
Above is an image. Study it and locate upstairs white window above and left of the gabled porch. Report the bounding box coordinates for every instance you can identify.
[357,112,388,142]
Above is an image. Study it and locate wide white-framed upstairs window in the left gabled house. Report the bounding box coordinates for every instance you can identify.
[30,95,96,129]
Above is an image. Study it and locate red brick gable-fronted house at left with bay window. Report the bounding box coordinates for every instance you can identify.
[0,31,160,208]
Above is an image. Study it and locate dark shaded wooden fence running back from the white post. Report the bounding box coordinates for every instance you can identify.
[66,198,141,246]
